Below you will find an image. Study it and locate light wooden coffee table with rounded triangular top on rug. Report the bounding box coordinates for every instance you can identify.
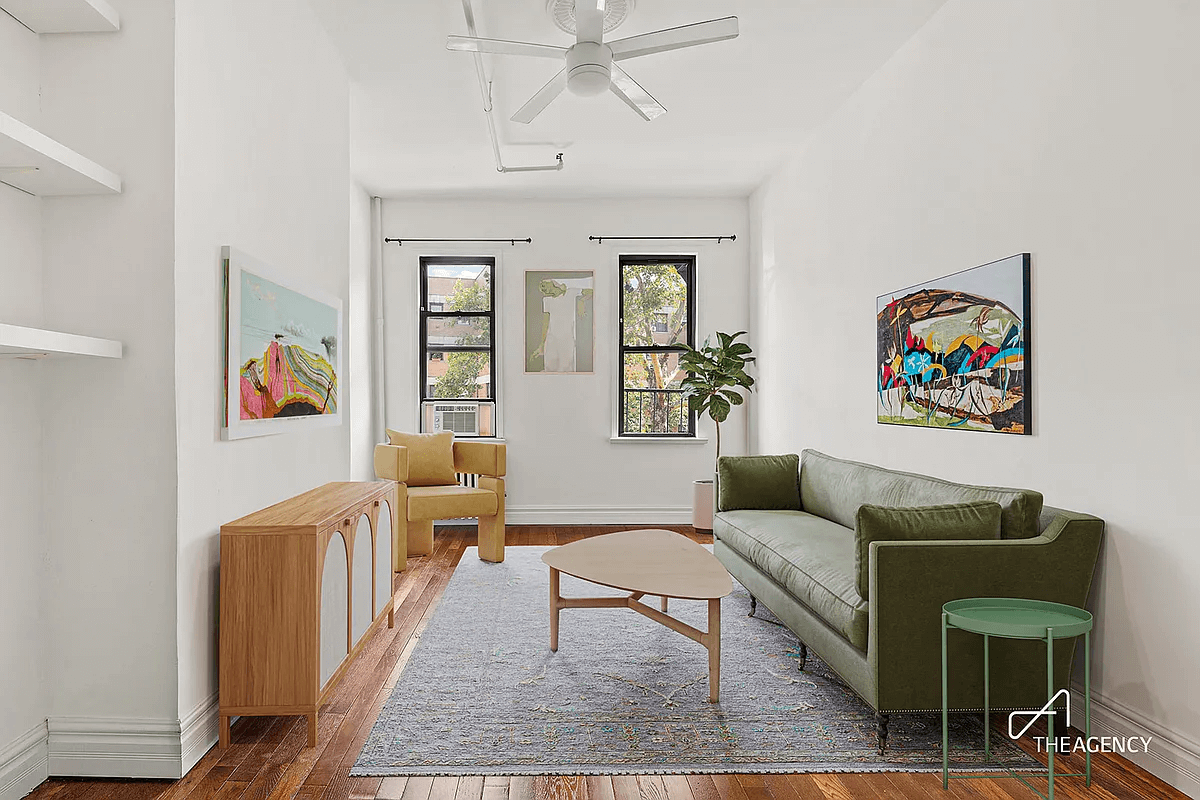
[541,529,733,703]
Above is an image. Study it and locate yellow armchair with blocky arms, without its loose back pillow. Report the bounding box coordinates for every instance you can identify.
[374,441,506,572]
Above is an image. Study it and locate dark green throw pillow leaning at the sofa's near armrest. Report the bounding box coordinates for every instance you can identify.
[854,500,1000,600]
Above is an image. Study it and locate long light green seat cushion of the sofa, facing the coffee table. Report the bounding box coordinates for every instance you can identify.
[713,511,868,650]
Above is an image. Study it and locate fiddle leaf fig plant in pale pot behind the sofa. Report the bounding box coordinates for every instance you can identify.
[679,331,755,530]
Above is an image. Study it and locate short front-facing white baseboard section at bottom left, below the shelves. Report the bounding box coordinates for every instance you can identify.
[47,717,184,778]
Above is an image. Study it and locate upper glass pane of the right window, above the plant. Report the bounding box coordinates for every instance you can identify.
[620,264,688,347]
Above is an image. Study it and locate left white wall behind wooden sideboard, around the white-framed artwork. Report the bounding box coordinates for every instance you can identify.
[174,0,357,769]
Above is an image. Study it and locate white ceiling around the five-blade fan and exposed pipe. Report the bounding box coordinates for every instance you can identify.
[310,0,946,198]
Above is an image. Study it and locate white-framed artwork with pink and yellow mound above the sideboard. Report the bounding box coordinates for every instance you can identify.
[221,247,342,439]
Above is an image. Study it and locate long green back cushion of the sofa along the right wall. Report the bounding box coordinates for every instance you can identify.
[800,450,1042,539]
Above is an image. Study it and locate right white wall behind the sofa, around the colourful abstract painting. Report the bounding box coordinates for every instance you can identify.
[752,0,1200,793]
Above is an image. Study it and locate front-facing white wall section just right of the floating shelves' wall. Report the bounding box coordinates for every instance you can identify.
[41,0,179,775]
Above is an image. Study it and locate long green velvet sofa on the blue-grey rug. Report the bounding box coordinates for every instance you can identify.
[713,450,1104,753]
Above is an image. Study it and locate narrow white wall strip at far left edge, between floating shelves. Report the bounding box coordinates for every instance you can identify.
[0,9,49,798]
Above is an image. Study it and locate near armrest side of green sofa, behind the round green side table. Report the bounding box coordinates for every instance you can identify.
[868,512,1104,711]
